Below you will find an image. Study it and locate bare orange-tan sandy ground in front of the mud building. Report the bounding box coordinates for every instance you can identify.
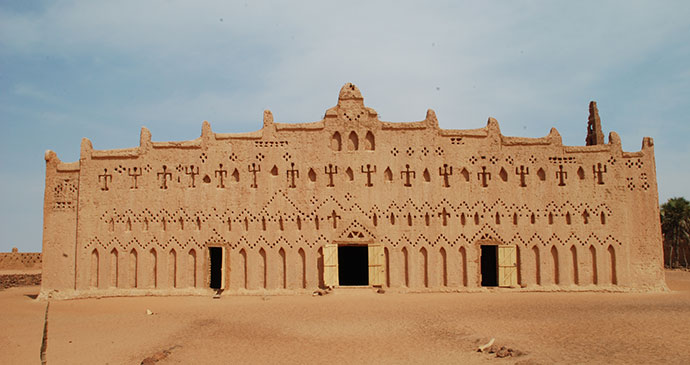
[0,271,690,364]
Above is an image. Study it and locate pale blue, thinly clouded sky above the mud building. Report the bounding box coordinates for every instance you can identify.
[0,0,690,252]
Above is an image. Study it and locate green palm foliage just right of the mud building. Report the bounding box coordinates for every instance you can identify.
[661,198,690,267]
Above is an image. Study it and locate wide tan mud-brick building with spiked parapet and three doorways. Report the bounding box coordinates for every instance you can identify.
[41,84,665,298]
